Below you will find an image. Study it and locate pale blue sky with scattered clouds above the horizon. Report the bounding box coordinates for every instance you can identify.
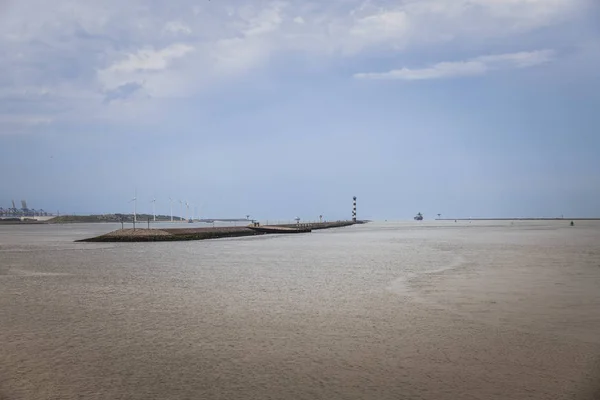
[0,0,600,220]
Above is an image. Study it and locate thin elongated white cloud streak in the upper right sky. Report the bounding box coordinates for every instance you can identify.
[354,50,555,81]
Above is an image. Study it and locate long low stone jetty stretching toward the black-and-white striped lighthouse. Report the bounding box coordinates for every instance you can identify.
[77,221,357,242]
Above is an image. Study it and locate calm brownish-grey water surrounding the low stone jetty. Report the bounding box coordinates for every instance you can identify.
[0,222,600,400]
